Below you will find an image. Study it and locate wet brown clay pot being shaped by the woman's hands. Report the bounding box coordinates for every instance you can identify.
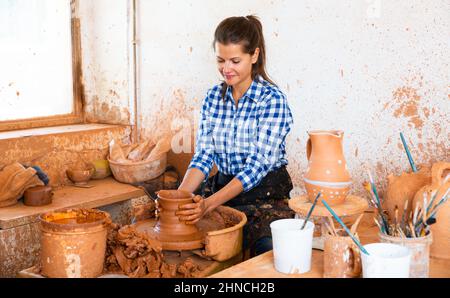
[153,190,204,250]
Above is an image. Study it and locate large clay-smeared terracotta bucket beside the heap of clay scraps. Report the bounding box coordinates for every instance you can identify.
[39,209,108,277]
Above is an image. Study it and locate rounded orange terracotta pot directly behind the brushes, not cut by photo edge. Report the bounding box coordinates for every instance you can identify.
[383,166,431,219]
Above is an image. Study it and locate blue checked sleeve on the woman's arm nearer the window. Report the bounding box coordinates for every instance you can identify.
[188,91,214,179]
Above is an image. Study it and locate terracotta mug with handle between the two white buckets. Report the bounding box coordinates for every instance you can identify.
[323,235,362,278]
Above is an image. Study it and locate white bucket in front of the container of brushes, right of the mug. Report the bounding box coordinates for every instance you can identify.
[361,243,411,278]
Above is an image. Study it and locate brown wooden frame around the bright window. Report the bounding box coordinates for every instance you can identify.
[0,0,85,131]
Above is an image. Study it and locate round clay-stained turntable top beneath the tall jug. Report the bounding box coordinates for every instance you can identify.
[289,195,369,217]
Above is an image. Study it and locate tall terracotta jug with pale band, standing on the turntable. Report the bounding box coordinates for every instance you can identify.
[304,130,352,205]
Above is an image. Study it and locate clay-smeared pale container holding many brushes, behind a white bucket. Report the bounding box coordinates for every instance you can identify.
[378,232,433,278]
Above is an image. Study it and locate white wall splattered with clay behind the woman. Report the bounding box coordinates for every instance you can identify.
[80,0,450,197]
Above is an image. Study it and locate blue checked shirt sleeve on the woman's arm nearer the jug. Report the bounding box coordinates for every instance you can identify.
[236,94,293,192]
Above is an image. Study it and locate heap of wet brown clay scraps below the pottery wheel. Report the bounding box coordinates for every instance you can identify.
[105,223,201,277]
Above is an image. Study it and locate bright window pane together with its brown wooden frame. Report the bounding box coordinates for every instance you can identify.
[0,0,81,130]
